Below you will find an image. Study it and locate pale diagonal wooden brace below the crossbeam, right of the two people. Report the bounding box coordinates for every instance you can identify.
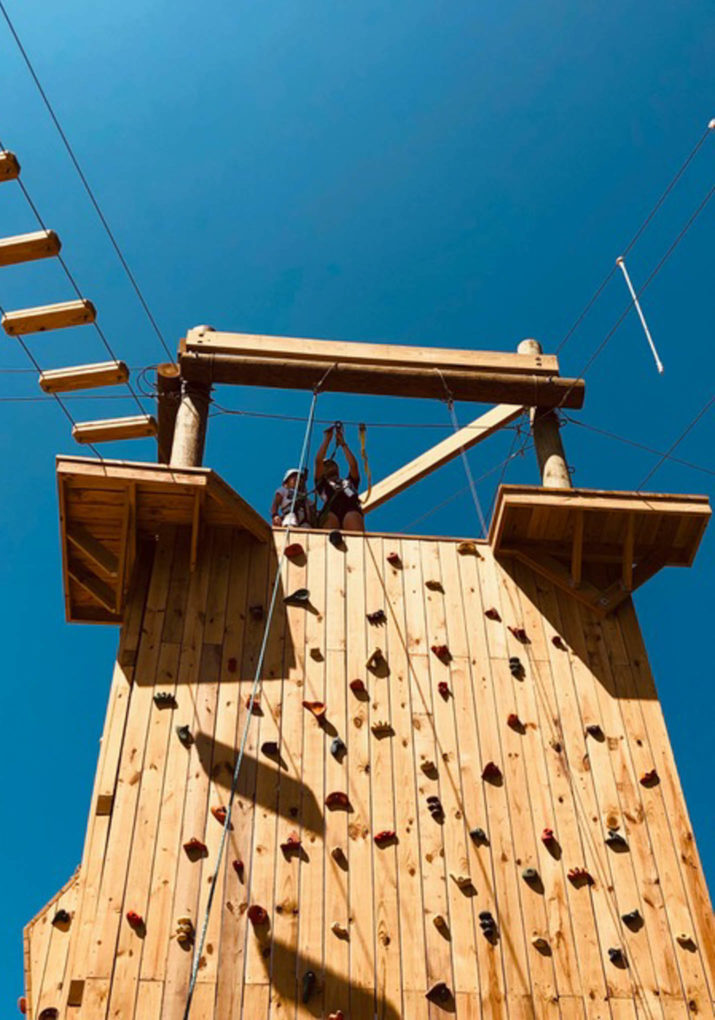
[360,405,524,513]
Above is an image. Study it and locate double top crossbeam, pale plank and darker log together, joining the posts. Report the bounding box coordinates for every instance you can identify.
[181,327,584,408]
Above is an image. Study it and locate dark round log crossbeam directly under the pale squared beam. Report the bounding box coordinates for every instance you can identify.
[181,350,584,408]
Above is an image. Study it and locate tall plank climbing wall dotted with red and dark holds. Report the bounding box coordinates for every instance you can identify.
[25,527,715,1020]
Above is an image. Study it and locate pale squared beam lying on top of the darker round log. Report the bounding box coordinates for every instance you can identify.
[179,326,559,376]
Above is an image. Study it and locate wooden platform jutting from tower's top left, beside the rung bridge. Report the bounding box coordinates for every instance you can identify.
[57,456,270,623]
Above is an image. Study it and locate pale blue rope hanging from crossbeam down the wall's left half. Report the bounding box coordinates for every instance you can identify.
[184,377,326,1020]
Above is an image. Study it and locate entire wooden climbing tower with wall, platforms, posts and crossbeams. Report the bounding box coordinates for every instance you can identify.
[19,326,715,1020]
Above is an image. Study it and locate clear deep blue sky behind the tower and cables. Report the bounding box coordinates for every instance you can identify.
[0,0,715,1003]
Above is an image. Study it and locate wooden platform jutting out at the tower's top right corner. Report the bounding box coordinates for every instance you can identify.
[490,486,712,615]
